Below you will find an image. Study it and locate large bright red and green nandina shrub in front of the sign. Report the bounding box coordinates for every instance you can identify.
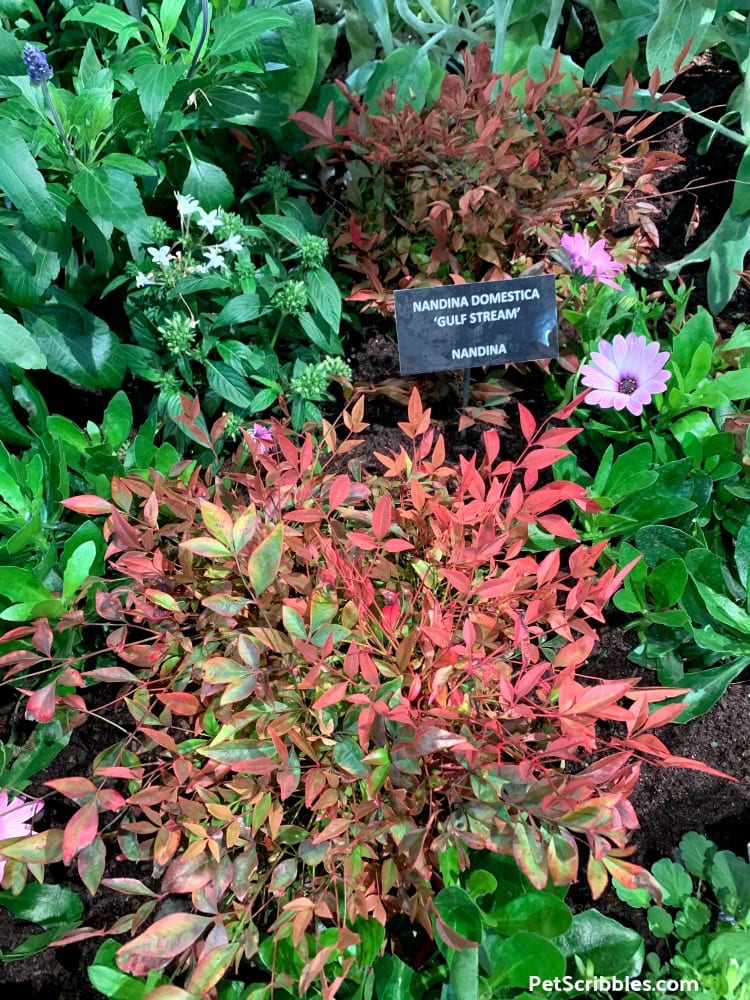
[0,390,728,997]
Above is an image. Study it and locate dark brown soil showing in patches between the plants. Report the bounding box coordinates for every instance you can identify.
[0,48,750,1000]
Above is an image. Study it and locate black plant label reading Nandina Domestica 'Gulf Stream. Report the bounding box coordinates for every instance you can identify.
[394,274,558,375]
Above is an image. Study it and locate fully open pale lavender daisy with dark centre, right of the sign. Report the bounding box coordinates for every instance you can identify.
[581,333,670,417]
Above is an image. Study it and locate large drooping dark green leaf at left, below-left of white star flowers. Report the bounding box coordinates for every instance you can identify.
[22,289,125,389]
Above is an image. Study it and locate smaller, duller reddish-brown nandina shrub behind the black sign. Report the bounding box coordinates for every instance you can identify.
[292,45,679,311]
